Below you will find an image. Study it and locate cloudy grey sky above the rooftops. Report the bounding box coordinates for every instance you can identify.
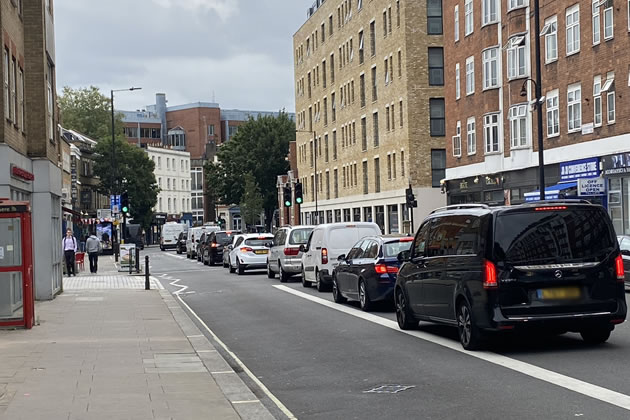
[55,0,312,112]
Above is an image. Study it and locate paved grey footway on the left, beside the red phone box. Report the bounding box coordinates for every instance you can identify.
[0,251,273,420]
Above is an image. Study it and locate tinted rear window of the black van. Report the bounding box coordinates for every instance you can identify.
[494,206,617,264]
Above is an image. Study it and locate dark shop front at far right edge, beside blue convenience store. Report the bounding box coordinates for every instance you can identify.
[602,152,630,235]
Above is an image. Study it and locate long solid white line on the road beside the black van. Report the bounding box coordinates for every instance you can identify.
[273,285,630,410]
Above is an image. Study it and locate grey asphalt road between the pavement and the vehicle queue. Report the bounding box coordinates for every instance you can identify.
[146,248,630,419]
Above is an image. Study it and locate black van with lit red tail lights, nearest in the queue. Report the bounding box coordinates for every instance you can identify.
[394,200,627,349]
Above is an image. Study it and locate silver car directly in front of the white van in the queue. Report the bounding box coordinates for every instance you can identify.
[267,226,313,283]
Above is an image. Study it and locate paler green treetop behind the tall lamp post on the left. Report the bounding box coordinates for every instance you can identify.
[58,86,123,144]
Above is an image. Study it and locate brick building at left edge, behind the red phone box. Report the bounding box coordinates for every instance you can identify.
[0,0,63,299]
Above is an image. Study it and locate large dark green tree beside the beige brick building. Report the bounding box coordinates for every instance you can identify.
[218,111,295,227]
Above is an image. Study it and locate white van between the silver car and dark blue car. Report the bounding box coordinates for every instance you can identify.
[300,222,381,292]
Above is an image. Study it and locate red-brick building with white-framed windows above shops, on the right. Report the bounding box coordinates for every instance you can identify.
[444,0,630,233]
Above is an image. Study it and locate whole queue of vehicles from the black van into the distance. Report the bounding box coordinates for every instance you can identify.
[162,200,630,350]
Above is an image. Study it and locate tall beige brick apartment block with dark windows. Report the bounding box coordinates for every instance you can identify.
[293,0,446,233]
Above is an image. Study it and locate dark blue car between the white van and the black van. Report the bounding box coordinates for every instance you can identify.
[333,236,413,311]
